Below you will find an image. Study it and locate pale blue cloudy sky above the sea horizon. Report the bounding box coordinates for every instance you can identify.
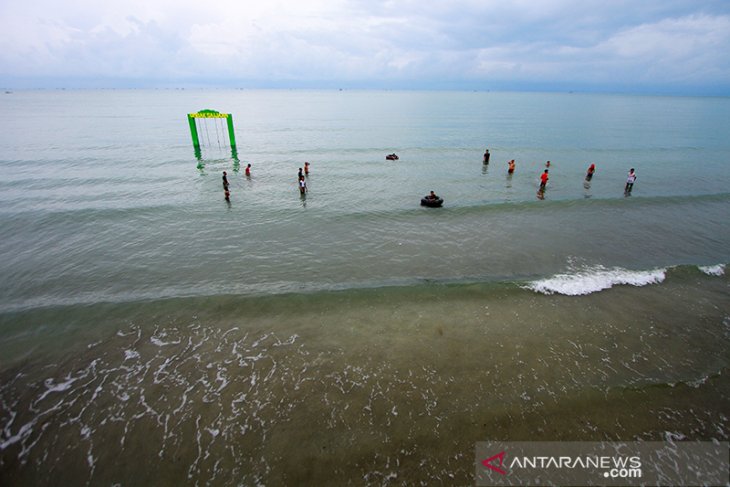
[0,0,730,96]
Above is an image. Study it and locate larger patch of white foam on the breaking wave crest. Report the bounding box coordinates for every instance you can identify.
[526,265,667,296]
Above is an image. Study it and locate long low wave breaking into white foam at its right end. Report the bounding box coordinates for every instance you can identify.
[0,264,730,319]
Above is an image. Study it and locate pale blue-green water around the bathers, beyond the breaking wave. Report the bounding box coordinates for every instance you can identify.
[0,90,730,309]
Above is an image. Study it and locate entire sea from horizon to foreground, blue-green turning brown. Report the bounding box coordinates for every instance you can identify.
[0,89,730,486]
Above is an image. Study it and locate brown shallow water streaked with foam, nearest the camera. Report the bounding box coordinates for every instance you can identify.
[0,268,730,485]
